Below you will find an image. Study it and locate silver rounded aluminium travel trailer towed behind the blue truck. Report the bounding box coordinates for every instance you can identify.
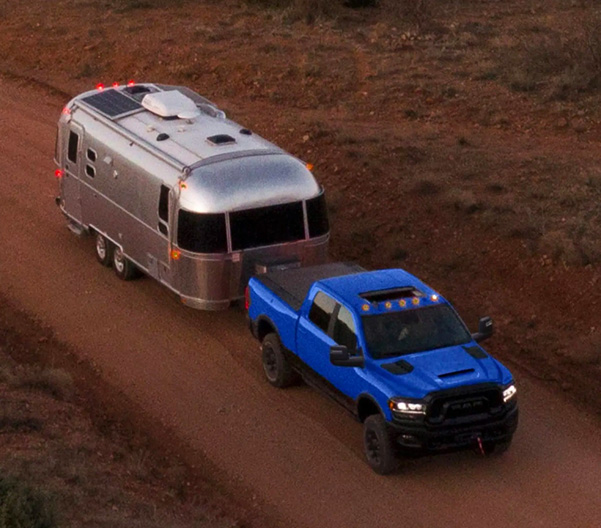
[55,83,329,310]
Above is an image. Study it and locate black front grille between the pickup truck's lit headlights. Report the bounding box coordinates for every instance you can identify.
[428,387,503,423]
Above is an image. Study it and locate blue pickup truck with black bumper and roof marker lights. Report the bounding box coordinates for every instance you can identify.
[246,263,518,474]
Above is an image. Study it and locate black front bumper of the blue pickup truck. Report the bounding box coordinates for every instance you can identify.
[390,403,519,453]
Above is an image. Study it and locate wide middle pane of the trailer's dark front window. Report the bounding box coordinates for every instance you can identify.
[230,202,305,251]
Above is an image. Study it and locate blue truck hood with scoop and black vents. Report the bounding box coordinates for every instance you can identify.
[373,344,511,398]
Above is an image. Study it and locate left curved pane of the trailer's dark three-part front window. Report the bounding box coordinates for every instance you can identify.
[177,210,227,253]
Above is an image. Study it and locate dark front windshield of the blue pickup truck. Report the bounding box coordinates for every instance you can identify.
[362,305,472,359]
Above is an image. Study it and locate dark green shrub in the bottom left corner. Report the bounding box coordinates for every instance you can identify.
[0,476,57,528]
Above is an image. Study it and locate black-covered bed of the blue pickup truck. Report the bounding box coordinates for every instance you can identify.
[255,262,366,312]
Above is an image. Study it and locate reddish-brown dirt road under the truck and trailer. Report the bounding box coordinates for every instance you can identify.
[0,78,601,528]
